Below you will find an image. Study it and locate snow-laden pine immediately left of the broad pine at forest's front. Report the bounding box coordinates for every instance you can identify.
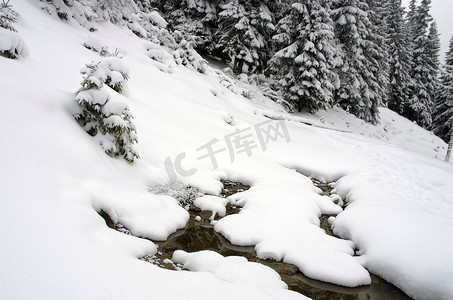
[216,0,274,74]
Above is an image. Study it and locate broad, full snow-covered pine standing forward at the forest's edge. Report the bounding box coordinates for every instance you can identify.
[268,0,338,111]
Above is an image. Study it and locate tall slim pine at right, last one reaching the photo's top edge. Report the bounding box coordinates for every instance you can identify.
[404,0,434,128]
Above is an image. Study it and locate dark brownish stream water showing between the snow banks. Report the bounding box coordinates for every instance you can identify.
[100,180,410,300]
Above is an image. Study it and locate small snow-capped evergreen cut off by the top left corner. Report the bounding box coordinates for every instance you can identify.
[0,1,28,58]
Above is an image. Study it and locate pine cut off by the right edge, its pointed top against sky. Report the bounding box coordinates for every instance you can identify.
[433,37,453,143]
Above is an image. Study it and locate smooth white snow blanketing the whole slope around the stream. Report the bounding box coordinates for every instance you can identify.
[0,1,453,299]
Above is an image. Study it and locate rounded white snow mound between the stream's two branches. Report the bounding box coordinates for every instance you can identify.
[214,164,371,287]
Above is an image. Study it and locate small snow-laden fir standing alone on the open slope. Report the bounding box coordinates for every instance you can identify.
[74,57,139,163]
